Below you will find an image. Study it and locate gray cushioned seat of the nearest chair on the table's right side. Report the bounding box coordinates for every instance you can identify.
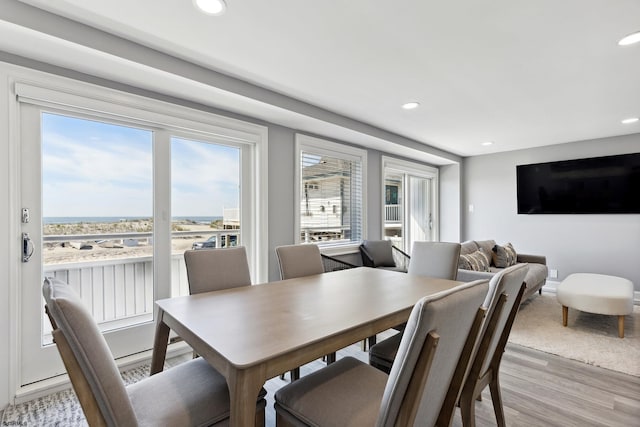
[275,357,389,427]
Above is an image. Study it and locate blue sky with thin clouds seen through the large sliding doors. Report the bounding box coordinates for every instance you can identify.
[42,113,240,217]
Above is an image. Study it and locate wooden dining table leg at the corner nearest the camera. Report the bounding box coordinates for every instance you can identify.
[227,367,266,427]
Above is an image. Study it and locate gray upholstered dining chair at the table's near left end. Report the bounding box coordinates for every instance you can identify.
[42,278,266,427]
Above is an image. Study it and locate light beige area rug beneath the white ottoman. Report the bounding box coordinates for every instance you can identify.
[509,293,640,377]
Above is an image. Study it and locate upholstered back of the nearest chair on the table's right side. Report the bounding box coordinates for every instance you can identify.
[376,280,489,427]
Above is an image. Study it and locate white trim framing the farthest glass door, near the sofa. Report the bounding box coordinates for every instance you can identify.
[380,156,440,242]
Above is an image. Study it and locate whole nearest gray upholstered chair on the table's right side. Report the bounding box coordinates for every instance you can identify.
[275,281,489,426]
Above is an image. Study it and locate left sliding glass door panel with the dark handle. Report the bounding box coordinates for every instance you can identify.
[20,109,154,385]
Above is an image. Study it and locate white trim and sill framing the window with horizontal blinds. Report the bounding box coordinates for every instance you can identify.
[293,134,367,247]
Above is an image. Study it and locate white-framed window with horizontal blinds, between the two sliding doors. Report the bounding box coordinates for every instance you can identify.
[295,135,366,245]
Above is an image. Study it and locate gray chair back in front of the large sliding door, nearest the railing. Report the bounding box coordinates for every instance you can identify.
[184,246,251,295]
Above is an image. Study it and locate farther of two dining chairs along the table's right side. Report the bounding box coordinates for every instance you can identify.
[459,264,529,427]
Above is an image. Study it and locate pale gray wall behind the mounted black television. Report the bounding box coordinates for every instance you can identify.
[462,134,640,291]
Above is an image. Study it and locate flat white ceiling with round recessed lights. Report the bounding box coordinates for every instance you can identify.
[0,0,640,157]
